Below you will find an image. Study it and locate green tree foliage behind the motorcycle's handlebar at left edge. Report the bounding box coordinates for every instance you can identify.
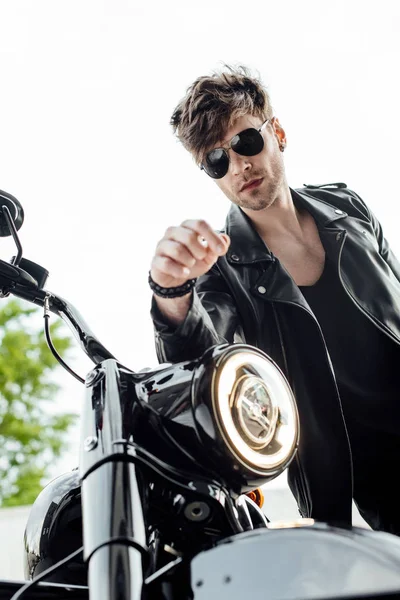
[0,300,76,506]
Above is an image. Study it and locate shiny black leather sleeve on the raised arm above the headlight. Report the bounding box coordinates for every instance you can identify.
[151,268,243,363]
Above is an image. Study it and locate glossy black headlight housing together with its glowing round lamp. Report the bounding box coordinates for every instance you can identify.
[136,344,299,494]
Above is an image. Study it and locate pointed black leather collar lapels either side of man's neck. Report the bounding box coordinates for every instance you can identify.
[225,189,348,265]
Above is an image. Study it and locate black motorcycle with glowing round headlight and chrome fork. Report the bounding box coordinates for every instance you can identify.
[0,191,400,600]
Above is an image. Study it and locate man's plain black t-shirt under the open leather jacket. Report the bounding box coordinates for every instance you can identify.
[300,258,400,450]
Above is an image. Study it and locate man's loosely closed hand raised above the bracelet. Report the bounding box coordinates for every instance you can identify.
[150,220,230,288]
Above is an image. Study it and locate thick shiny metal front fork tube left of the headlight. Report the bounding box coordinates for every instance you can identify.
[80,359,147,600]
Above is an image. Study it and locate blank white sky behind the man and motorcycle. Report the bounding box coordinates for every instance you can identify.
[0,0,400,486]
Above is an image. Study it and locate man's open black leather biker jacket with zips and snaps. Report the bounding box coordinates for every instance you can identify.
[152,184,400,524]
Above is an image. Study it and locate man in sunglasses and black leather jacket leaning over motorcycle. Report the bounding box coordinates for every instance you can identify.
[149,68,400,534]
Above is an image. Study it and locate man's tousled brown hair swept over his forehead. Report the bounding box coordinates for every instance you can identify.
[171,65,272,163]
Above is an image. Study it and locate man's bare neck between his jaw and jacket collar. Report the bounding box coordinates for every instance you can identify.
[242,184,302,240]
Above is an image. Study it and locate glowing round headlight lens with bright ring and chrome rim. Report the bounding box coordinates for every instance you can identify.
[212,345,299,476]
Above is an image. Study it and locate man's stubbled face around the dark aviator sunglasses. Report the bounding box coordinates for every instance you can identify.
[205,115,286,211]
